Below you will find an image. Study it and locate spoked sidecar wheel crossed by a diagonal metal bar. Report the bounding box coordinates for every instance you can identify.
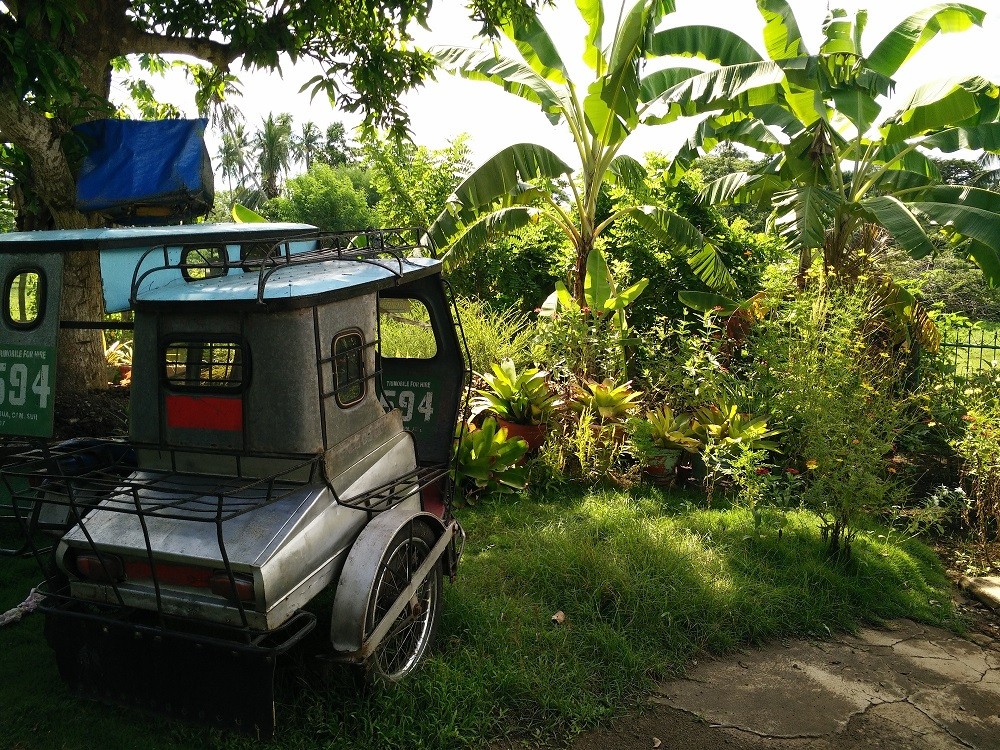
[365,523,441,682]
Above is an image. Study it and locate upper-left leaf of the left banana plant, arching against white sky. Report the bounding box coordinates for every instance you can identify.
[429,47,566,124]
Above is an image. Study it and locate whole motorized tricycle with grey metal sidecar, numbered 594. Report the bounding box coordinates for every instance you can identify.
[0,223,467,737]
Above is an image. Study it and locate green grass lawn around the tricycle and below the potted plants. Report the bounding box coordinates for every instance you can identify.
[0,488,954,750]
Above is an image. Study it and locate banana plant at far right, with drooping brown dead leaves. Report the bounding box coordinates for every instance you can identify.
[650,0,1000,292]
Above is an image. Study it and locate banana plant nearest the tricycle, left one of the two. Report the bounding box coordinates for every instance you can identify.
[426,0,782,305]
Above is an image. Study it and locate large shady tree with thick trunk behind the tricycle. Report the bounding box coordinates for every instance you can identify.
[0,0,540,392]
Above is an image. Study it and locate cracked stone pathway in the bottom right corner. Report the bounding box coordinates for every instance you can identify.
[650,620,1000,750]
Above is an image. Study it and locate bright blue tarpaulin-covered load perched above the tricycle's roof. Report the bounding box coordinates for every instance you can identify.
[73,119,215,224]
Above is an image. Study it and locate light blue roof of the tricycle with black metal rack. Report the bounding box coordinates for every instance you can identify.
[0,223,440,312]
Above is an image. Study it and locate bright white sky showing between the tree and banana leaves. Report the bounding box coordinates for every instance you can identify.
[121,0,1000,170]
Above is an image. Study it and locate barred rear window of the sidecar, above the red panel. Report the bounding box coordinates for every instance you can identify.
[162,338,249,393]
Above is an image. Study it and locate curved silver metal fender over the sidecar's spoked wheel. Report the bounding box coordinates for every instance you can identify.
[330,505,445,653]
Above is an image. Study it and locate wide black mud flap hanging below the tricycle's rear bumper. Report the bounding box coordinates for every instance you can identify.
[45,607,311,739]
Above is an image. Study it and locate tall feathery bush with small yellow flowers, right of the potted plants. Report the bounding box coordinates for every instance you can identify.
[752,288,910,552]
